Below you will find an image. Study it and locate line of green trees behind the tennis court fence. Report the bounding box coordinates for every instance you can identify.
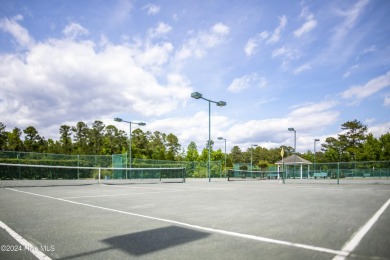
[0,119,390,168]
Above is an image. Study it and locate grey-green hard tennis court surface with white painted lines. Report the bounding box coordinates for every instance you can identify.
[0,179,390,259]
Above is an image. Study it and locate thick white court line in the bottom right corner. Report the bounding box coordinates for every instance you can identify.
[333,199,390,260]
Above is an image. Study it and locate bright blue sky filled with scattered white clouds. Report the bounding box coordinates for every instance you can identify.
[0,0,390,152]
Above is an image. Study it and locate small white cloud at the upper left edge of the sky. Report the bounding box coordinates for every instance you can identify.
[0,15,34,48]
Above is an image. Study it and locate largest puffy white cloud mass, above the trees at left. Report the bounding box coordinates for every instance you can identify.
[0,19,192,132]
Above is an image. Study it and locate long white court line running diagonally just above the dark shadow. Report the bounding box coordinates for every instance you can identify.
[7,188,349,256]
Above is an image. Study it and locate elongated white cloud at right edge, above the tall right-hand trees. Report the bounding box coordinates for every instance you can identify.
[341,71,390,101]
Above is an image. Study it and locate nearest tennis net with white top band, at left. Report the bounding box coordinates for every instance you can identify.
[0,163,186,187]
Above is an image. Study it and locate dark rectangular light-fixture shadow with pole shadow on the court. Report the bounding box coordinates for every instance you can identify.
[61,226,210,259]
